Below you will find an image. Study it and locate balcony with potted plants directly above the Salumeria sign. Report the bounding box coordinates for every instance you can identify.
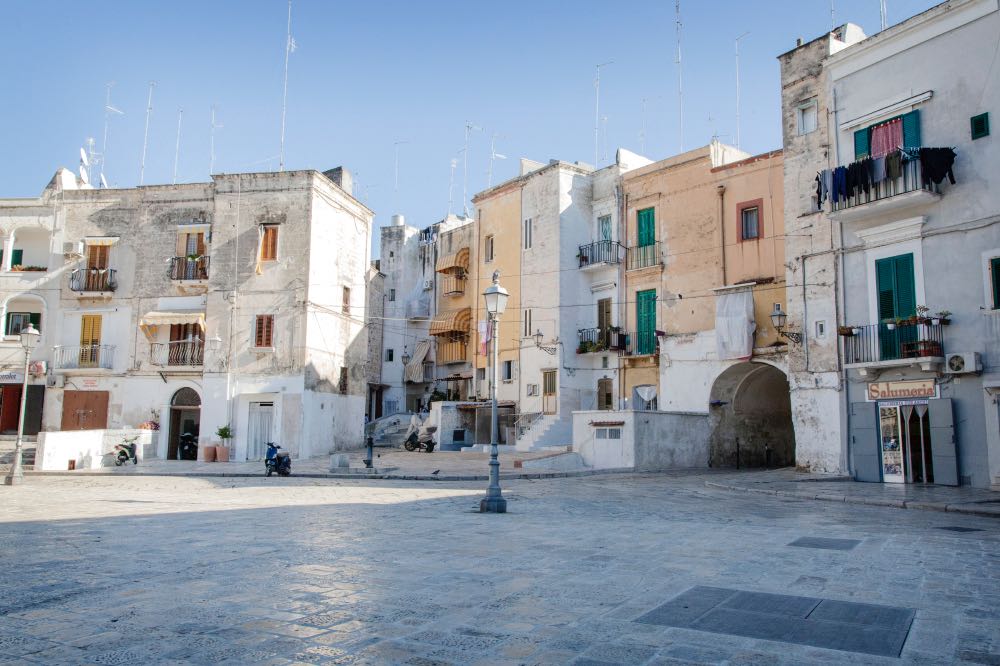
[843,323,944,375]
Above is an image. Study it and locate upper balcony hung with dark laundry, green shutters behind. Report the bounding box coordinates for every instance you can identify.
[815,110,957,222]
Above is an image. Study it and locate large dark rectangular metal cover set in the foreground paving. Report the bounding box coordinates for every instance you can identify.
[635,586,914,657]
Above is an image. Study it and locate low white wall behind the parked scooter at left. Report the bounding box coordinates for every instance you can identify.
[35,428,159,471]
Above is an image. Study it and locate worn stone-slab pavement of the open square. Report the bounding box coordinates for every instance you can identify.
[0,473,1000,665]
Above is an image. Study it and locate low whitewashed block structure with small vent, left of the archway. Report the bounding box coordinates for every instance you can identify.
[573,411,710,472]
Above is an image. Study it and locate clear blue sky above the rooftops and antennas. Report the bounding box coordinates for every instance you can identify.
[0,0,936,244]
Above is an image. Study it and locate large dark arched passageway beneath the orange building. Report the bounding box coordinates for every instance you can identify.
[709,363,795,467]
